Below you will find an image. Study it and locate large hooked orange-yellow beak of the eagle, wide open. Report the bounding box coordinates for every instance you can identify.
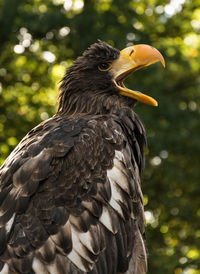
[111,44,165,106]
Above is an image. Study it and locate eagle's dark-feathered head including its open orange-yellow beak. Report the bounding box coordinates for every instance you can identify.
[58,41,165,114]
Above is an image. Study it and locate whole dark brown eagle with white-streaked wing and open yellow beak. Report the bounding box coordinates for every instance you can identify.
[0,41,165,274]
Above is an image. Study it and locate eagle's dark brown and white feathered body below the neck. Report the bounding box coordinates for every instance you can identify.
[0,108,146,274]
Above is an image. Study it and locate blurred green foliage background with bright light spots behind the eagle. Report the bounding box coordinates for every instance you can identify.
[0,0,200,274]
